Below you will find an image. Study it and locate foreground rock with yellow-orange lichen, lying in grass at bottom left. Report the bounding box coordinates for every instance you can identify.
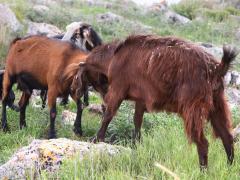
[0,138,130,179]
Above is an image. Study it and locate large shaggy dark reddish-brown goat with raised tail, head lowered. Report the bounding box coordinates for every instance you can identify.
[72,35,237,167]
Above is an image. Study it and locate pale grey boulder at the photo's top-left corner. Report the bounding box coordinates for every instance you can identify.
[0,4,23,32]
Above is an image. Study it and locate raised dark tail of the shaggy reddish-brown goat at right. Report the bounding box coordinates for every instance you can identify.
[219,46,239,77]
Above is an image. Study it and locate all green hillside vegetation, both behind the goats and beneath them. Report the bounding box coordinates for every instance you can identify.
[0,0,240,179]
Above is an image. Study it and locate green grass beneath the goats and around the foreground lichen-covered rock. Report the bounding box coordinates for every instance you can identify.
[0,92,240,179]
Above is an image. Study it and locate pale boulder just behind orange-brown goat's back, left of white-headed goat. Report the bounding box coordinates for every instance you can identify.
[27,22,62,37]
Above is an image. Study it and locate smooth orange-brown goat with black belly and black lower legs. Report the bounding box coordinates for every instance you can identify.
[2,36,87,138]
